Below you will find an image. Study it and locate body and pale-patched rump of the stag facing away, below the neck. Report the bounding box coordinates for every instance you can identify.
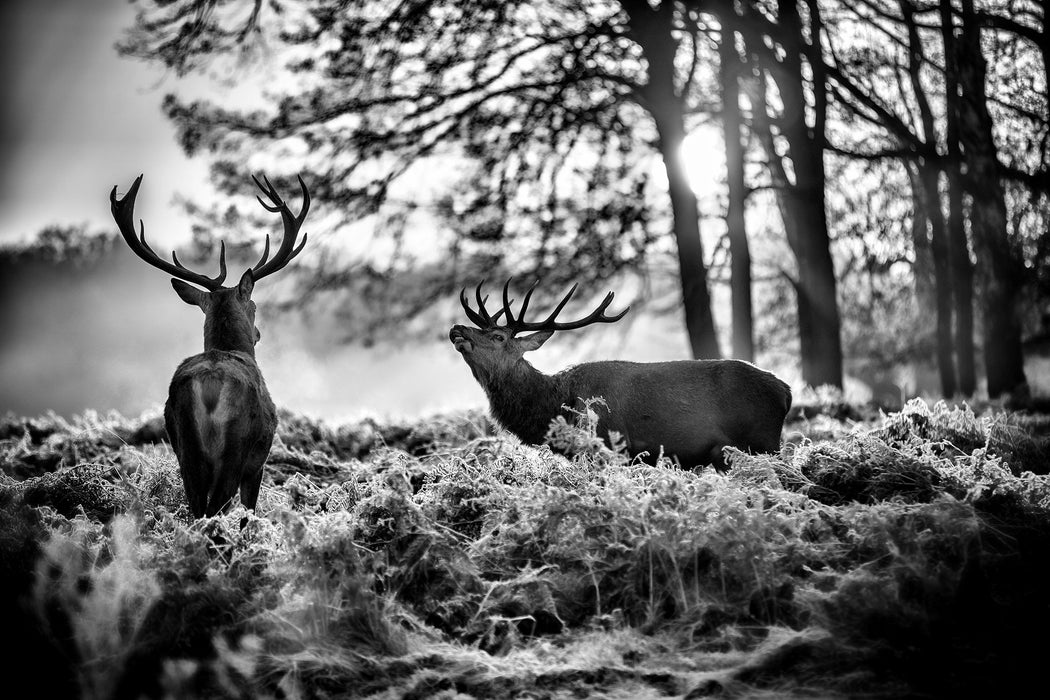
[164,351,277,517]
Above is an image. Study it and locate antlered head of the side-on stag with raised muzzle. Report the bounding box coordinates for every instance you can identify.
[448,279,630,384]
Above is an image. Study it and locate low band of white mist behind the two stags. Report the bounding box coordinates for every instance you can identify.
[0,246,705,421]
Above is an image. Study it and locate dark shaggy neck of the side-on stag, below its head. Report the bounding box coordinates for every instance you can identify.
[479,359,566,444]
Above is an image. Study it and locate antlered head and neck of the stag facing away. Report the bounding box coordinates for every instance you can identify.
[109,175,310,356]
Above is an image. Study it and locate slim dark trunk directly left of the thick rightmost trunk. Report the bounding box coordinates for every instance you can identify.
[941,0,978,396]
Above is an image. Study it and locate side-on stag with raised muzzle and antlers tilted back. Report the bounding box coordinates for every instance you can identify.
[448,280,791,471]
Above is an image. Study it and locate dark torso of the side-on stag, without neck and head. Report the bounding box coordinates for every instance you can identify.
[555,360,792,471]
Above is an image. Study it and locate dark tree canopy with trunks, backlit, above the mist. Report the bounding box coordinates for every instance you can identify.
[119,0,1050,395]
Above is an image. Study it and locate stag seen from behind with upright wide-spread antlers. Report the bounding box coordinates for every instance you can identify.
[109,175,310,517]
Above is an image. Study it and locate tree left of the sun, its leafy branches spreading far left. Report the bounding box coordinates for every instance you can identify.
[120,0,719,357]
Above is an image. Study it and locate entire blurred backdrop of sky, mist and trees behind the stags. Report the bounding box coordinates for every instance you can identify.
[0,0,1050,420]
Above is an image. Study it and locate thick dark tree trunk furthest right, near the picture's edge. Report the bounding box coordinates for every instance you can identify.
[957,0,1026,398]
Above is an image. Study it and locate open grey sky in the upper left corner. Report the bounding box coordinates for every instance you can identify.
[0,0,209,248]
